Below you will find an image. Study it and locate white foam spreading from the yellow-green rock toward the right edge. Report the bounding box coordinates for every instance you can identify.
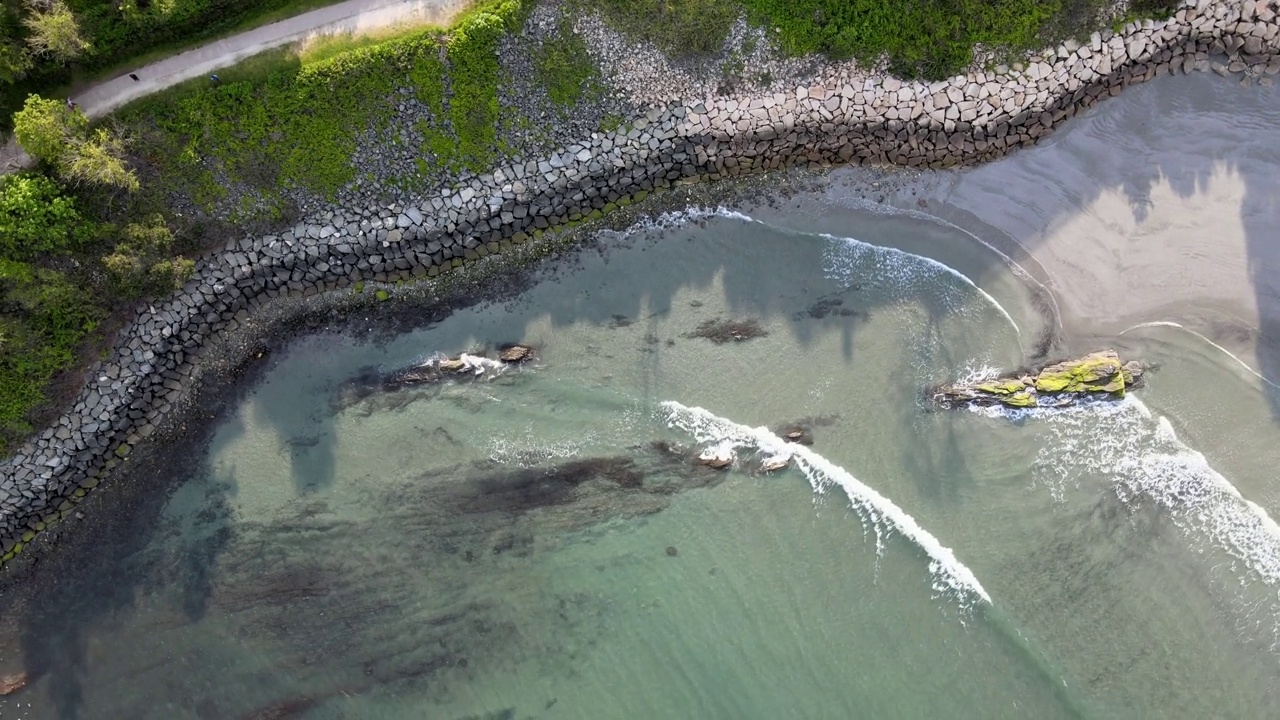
[975,396,1280,587]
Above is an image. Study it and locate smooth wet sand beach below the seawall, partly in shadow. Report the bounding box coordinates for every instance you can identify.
[870,74,1280,366]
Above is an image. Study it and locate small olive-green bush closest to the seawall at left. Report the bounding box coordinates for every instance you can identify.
[102,215,196,296]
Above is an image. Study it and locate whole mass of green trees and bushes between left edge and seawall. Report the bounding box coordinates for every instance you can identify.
[0,165,192,455]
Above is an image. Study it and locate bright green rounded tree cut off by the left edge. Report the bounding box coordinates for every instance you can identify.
[0,173,88,258]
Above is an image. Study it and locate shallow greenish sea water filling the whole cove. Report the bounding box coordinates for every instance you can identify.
[0,203,1280,719]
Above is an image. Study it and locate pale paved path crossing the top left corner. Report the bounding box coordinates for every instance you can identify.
[0,0,468,174]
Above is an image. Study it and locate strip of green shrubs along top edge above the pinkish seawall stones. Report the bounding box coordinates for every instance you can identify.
[588,0,1176,79]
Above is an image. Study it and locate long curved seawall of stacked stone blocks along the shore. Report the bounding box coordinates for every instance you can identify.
[0,0,1280,560]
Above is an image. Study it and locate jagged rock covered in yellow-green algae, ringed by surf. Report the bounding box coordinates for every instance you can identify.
[933,350,1144,407]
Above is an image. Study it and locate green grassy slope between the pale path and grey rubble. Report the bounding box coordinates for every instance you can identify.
[116,0,526,210]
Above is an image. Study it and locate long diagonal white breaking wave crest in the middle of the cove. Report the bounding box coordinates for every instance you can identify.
[662,401,991,606]
